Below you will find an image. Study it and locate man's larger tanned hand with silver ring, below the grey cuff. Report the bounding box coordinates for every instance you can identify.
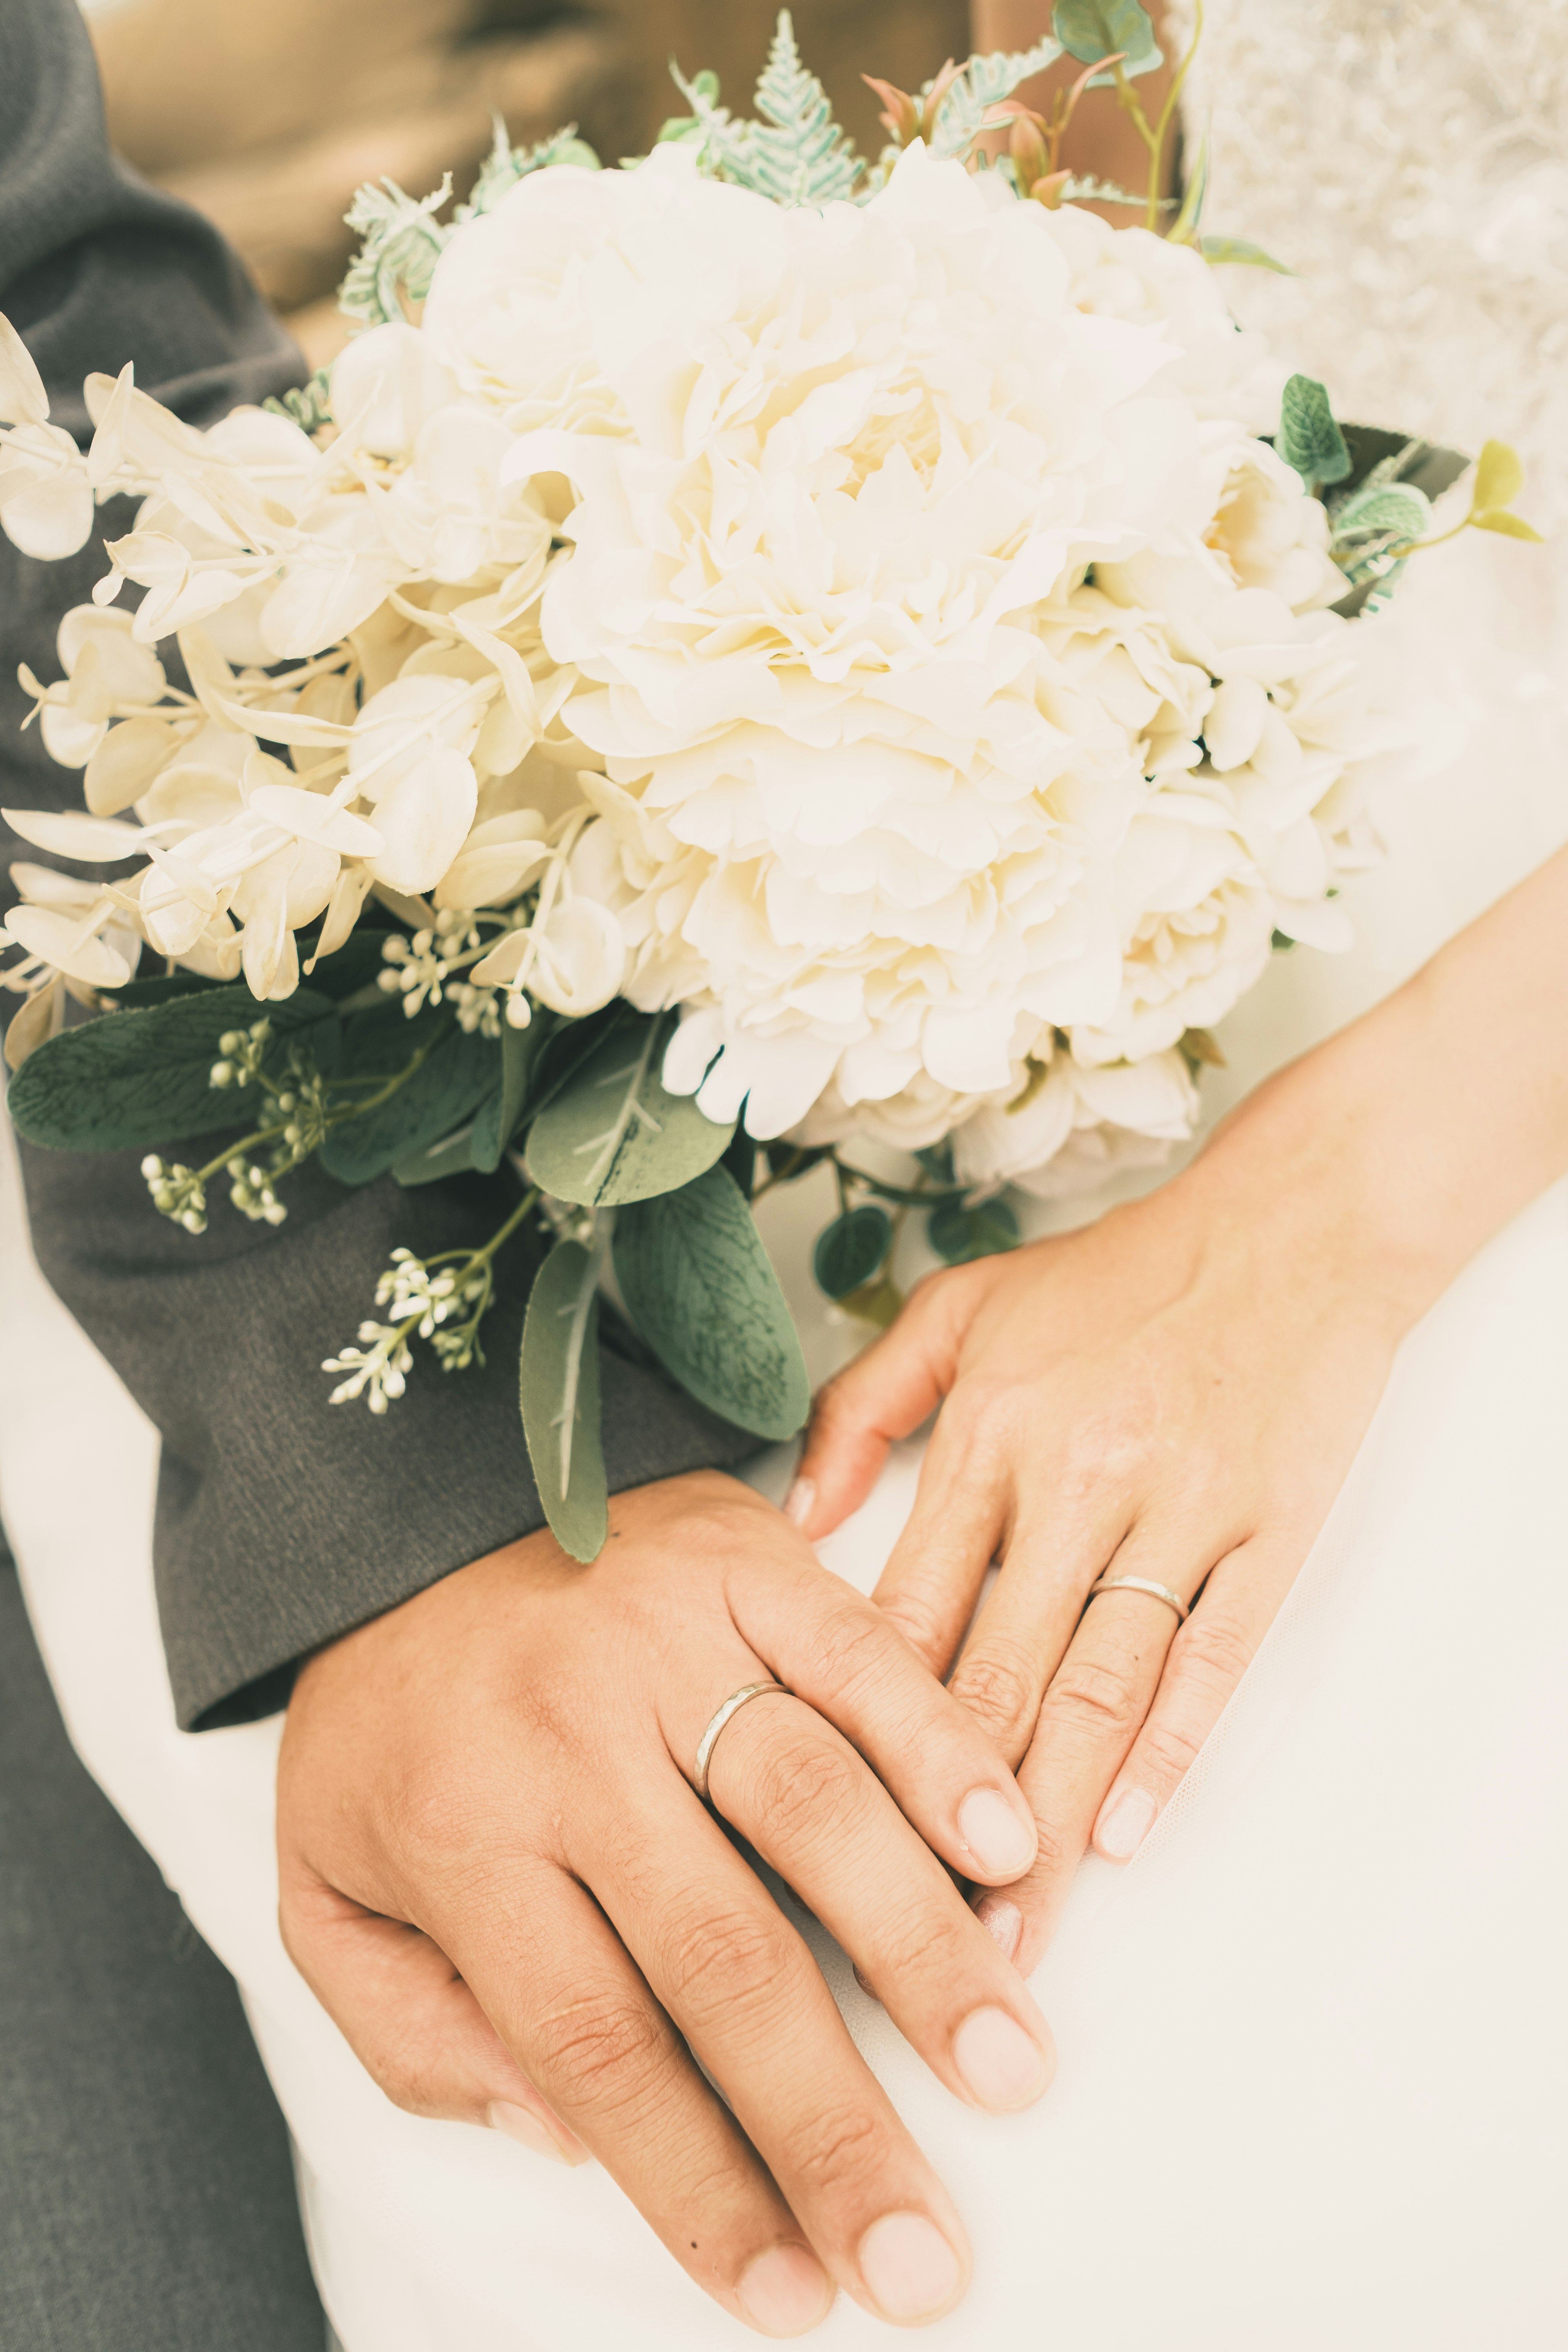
[277,1472,1051,2336]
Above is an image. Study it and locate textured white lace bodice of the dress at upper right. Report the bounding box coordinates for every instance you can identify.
[1168,0,1568,527]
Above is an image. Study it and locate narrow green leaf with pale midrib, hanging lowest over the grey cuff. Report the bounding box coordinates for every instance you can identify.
[517,1242,609,1562]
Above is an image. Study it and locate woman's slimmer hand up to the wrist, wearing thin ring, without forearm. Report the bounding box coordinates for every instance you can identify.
[795,1138,1401,1973]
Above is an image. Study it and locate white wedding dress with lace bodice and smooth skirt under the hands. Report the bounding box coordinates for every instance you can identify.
[0,0,1568,2352]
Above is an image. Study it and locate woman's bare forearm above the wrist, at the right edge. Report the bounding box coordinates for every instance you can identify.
[1183,849,1568,1322]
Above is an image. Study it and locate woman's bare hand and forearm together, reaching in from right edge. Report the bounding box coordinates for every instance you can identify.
[790,851,1568,1973]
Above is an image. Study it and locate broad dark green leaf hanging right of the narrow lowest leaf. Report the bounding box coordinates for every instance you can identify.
[611,1167,811,1439]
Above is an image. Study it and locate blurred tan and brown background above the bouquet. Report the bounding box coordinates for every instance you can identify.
[87,0,969,362]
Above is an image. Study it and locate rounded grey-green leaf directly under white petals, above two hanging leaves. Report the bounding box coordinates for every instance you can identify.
[527,1014,736,1209]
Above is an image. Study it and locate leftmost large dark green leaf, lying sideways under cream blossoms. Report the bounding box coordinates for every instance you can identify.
[7,988,336,1152]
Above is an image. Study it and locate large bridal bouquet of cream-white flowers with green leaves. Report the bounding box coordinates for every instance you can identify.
[0,0,1526,1559]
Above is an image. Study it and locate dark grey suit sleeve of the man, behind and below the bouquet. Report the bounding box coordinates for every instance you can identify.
[0,0,755,1729]
